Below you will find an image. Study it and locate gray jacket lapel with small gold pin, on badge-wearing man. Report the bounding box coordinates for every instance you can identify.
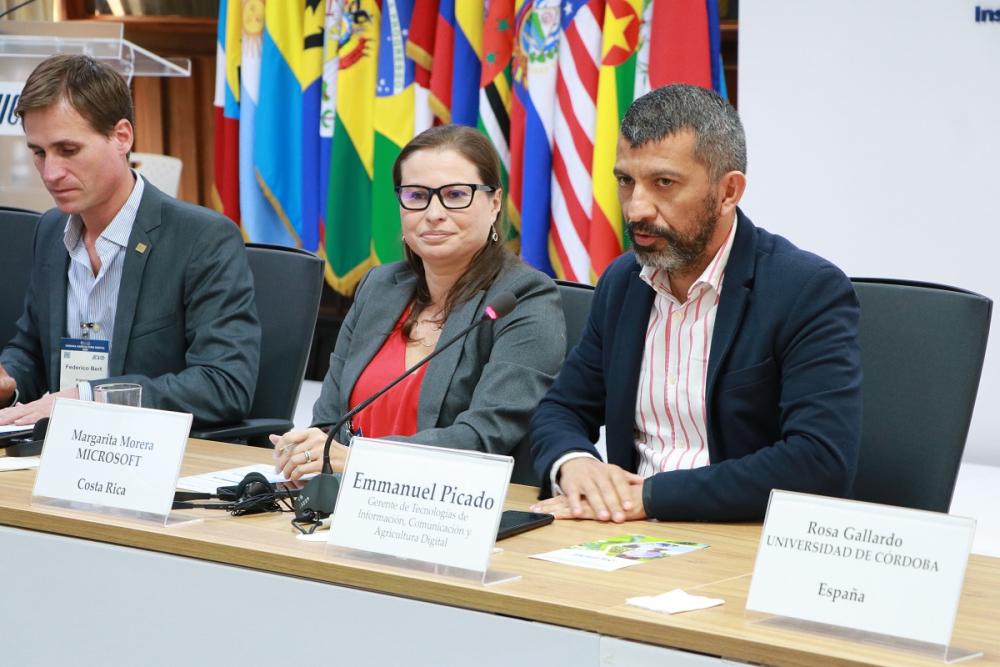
[108,181,164,377]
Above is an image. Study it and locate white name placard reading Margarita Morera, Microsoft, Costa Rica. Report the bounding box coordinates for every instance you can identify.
[32,398,191,518]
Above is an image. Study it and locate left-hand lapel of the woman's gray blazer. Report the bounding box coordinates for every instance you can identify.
[340,271,417,413]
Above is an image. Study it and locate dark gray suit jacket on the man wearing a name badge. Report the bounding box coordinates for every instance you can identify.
[0,181,260,424]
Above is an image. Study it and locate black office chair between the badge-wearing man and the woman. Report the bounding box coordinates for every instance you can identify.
[191,243,323,446]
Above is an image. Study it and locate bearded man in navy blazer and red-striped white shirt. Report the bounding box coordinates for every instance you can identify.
[531,85,861,522]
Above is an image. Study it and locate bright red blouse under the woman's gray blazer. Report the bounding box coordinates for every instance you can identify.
[349,308,427,438]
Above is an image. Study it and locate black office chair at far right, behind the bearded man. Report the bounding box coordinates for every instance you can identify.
[851,278,993,512]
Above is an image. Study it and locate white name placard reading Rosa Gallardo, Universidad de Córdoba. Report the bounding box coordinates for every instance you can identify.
[747,491,976,646]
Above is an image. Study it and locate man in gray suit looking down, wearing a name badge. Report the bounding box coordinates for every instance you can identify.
[0,56,260,425]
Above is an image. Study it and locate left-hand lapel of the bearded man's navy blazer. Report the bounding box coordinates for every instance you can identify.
[605,265,656,470]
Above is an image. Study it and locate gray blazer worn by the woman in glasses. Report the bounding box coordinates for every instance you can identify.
[313,260,566,481]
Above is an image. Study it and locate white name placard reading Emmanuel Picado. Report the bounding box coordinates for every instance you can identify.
[330,438,513,572]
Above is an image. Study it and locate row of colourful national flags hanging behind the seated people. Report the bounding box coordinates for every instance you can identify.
[214,0,726,294]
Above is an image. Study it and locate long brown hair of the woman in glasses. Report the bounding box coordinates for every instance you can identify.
[392,125,514,338]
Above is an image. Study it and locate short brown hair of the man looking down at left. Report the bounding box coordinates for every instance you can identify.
[15,55,135,137]
